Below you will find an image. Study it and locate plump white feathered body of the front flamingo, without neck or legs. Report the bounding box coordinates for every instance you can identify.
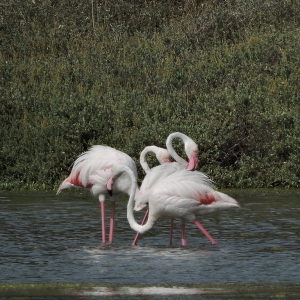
[149,170,238,222]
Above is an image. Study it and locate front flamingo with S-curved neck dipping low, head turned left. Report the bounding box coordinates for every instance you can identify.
[107,165,239,246]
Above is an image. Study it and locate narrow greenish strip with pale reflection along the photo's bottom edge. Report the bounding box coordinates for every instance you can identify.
[0,282,300,299]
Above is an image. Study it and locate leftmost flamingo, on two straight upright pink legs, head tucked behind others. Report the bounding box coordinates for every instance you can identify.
[57,145,169,243]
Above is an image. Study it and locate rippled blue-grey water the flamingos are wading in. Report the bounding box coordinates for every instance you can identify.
[0,189,300,299]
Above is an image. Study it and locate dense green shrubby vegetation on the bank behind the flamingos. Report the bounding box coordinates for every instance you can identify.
[0,0,300,190]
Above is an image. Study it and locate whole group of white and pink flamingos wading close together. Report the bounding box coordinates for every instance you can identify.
[57,132,239,246]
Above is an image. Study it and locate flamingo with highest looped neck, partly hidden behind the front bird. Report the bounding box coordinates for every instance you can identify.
[133,132,208,245]
